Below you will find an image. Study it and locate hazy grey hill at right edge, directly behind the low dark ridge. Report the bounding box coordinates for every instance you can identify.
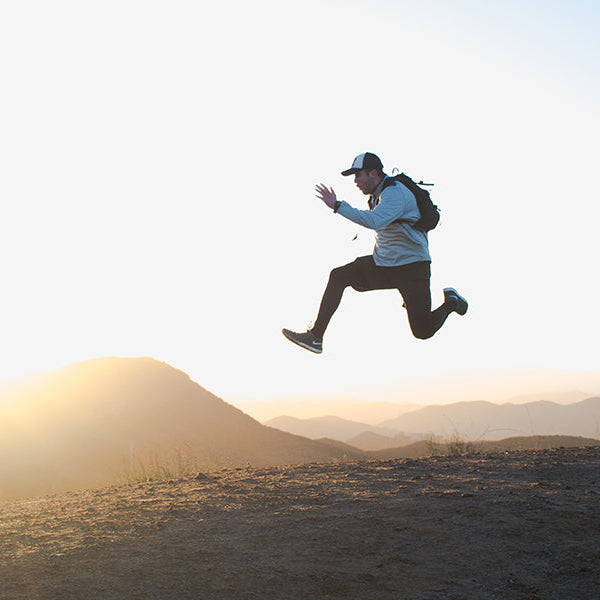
[381,398,600,440]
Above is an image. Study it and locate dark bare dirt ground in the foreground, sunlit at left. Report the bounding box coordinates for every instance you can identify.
[0,447,600,600]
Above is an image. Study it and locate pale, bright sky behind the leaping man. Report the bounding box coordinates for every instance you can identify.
[0,0,600,408]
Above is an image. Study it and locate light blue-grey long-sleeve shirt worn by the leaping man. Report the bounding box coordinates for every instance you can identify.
[337,177,431,267]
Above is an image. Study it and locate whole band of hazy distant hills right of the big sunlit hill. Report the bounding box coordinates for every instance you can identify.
[267,398,600,450]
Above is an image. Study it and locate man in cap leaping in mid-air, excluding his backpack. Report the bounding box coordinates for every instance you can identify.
[282,152,468,354]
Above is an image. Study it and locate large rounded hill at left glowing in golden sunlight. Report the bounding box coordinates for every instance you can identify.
[0,358,360,498]
